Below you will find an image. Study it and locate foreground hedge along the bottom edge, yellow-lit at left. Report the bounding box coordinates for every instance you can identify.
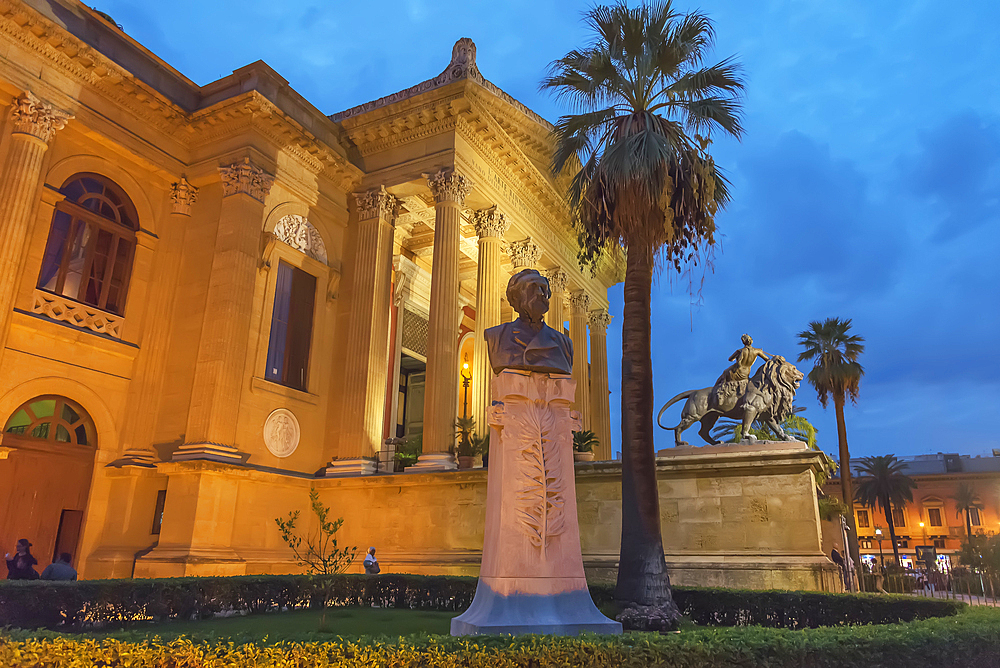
[0,608,1000,668]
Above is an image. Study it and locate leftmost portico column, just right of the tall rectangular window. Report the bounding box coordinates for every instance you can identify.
[327,187,399,474]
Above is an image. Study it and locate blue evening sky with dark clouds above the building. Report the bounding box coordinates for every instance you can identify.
[95,0,1000,456]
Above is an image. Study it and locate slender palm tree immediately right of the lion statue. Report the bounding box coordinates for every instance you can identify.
[798,318,865,576]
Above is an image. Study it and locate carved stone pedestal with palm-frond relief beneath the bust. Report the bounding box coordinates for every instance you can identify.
[451,369,622,635]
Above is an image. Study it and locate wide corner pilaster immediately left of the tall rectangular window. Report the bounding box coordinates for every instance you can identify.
[180,158,274,462]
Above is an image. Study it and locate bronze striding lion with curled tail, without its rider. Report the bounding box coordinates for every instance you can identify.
[656,355,803,446]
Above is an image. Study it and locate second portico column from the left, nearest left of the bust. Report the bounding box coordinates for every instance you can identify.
[410,169,472,472]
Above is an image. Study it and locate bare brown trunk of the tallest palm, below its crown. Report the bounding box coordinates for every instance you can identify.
[615,247,680,630]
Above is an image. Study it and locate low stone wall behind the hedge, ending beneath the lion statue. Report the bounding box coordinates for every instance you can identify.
[123,443,839,590]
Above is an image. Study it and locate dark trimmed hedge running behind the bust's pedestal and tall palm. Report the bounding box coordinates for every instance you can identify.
[0,574,965,630]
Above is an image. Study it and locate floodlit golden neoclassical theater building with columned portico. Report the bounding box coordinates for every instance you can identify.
[0,0,621,578]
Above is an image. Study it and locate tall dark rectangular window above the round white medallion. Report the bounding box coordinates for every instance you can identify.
[264,262,316,392]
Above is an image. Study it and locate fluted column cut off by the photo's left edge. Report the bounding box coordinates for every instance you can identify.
[0,92,73,354]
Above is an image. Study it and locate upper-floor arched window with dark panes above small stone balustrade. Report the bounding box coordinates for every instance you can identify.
[38,174,138,315]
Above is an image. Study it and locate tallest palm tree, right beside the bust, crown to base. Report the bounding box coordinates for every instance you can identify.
[541,0,743,630]
